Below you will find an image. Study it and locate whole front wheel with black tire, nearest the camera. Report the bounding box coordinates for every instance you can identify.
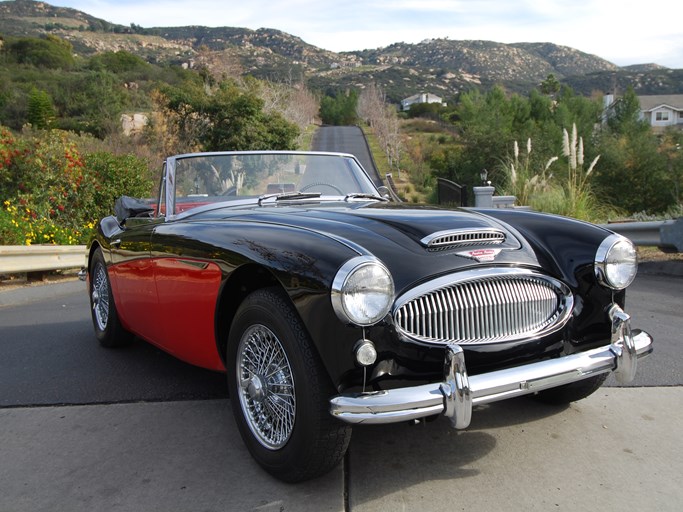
[226,288,351,482]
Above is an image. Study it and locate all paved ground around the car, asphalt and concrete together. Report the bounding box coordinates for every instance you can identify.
[0,275,683,512]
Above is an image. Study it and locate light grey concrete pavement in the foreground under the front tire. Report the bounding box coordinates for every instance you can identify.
[0,387,683,512]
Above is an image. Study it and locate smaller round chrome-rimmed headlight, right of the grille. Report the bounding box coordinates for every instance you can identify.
[595,235,638,290]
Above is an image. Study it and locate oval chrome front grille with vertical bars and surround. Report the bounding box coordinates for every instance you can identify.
[392,268,574,345]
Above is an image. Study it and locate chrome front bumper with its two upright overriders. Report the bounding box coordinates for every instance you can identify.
[330,304,652,429]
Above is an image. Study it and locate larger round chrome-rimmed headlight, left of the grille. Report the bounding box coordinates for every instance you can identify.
[332,256,394,327]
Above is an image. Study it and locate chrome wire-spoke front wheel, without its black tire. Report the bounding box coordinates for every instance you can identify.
[236,325,296,450]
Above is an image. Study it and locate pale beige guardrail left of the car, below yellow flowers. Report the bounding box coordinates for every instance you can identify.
[0,245,86,274]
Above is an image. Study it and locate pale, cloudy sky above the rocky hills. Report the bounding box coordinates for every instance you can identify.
[47,0,683,69]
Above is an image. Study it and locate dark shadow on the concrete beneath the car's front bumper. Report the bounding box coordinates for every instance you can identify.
[347,397,569,503]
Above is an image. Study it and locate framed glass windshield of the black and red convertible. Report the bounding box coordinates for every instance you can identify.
[167,152,379,213]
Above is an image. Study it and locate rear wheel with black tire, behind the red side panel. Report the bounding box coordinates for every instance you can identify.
[89,248,133,348]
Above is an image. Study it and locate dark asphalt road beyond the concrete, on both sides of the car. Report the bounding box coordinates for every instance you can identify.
[0,275,683,407]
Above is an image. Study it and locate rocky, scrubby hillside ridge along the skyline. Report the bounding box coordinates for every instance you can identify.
[0,0,683,101]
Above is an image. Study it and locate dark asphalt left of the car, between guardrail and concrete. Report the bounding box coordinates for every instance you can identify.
[0,281,227,407]
